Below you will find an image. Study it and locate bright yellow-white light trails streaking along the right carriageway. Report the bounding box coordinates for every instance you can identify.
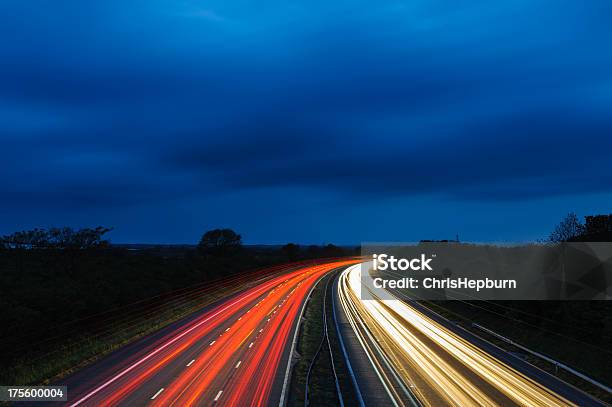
[338,264,574,406]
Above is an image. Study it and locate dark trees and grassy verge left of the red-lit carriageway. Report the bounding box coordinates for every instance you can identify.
[0,227,354,385]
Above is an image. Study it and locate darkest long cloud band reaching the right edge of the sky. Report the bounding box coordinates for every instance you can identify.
[160,110,612,200]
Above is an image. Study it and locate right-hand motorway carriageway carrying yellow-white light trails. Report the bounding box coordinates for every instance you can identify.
[336,265,601,406]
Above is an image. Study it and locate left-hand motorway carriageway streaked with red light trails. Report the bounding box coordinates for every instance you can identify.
[57,260,356,406]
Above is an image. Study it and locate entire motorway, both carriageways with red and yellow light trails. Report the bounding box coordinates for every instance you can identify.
[44,260,601,406]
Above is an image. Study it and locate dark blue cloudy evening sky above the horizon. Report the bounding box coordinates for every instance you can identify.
[0,0,612,244]
